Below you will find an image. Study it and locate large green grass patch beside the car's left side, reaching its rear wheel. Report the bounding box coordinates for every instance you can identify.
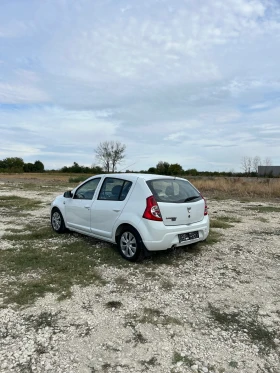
[0,225,137,305]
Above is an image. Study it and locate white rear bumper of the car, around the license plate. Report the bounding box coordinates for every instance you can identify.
[140,215,209,251]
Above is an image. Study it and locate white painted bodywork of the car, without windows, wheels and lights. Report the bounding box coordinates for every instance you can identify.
[51,173,209,251]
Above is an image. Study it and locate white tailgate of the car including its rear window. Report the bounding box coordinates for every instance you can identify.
[147,178,204,225]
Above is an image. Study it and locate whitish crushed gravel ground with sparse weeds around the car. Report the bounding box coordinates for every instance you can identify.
[0,183,280,373]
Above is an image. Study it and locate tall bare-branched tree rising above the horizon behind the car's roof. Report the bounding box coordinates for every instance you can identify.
[95,141,126,172]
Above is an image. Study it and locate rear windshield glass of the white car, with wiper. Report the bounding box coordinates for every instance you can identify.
[147,179,202,203]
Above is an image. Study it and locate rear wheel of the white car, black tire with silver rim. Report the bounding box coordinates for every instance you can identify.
[117,227,143,262]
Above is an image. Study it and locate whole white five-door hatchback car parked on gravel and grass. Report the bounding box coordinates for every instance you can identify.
[51,173,209,261]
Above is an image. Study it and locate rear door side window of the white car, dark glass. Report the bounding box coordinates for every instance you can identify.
[98,177,132,201]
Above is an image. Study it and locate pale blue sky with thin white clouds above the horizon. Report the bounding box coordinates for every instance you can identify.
[0,0,280,172]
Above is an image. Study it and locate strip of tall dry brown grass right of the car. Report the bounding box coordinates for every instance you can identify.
[189,177,280,199]
